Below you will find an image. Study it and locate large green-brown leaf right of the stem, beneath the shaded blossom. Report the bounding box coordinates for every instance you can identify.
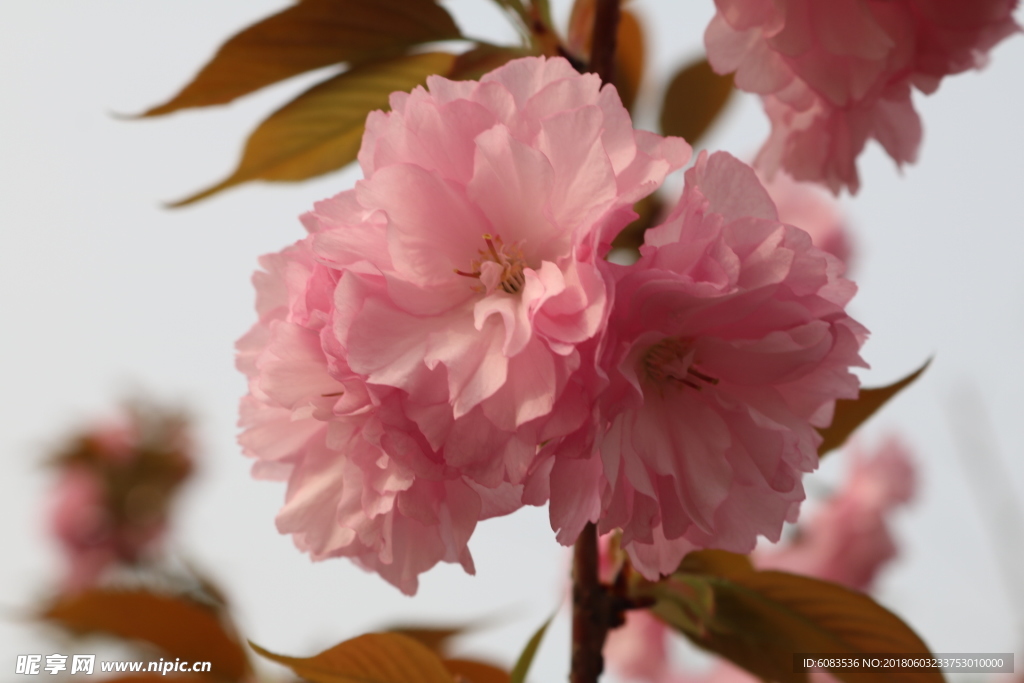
[641,551,942,683]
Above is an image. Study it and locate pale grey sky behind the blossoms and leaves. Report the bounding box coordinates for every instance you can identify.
[0,0,1024,680]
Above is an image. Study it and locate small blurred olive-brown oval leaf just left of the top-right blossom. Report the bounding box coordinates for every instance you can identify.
[662,59,732,144]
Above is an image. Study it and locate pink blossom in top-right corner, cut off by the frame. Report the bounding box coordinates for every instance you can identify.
[705,0,1020,193]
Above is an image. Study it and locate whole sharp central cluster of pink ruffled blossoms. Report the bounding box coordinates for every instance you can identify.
[238,57,866,593]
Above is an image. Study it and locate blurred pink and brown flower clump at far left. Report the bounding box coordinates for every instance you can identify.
[49,405,191,591]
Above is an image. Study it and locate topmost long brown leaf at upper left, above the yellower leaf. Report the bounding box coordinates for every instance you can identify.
[142,0,460,116]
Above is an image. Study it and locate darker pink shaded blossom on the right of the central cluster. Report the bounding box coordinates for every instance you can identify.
[551,153,866,580]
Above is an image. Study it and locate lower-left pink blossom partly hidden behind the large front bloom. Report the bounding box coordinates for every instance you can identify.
[238,238,519,594]
